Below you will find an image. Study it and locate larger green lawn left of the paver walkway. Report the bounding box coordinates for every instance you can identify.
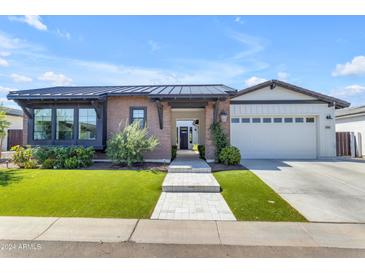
[0,169,165,218]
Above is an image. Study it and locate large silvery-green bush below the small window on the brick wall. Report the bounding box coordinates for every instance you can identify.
[106,121,159,166]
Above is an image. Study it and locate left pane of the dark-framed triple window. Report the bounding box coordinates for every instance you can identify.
[33,108,52,140]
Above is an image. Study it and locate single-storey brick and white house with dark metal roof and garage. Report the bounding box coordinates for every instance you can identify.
[8,80,349,161]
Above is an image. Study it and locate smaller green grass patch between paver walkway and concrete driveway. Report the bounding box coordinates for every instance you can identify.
[214,170,307,222]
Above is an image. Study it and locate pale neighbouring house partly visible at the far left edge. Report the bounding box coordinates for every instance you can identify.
[1,107,23,151]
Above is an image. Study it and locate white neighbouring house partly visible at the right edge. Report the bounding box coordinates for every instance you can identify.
[336,106,365,157]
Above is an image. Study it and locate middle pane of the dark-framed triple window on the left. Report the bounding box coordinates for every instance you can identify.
[56,109,74,140]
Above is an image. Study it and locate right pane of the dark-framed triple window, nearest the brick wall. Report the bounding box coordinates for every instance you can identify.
[79,108,96,140]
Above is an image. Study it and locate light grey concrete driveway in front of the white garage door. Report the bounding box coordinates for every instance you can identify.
[242,160,365,223]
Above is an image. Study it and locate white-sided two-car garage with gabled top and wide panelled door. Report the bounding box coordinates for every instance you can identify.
[230,80,347,159]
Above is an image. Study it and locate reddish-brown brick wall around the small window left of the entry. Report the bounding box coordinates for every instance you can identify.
[107,96,171,160]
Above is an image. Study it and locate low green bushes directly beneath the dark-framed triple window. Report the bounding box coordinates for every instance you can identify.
[33,146,95,169]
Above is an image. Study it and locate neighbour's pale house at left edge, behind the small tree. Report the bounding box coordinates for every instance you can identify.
[2,107,23,151]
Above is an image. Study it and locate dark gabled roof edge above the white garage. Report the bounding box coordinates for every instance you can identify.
[235,80,350,108]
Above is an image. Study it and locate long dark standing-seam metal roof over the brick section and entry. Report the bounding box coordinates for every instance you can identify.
[8,84,237,100]
